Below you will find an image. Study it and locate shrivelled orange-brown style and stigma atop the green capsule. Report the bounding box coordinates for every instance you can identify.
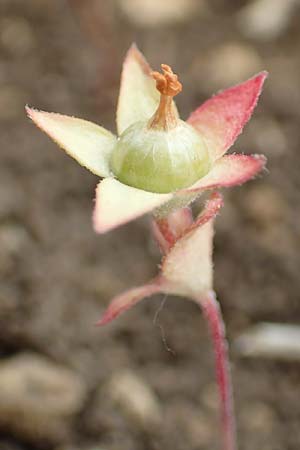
[148,64,182,131]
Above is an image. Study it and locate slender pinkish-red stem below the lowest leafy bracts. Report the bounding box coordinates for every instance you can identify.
[200,293,237,450]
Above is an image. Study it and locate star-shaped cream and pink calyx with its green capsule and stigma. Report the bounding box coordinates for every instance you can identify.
[27,45,266,233]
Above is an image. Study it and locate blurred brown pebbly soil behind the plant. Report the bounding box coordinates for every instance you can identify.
[0,0,300,450]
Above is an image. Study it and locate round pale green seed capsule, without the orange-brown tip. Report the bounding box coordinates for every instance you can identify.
[110,120,211,193]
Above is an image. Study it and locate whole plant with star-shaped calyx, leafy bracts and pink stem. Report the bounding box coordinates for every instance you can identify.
[26,45,266,450]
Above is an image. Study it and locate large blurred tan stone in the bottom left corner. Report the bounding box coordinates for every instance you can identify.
[0,353,85,442]
